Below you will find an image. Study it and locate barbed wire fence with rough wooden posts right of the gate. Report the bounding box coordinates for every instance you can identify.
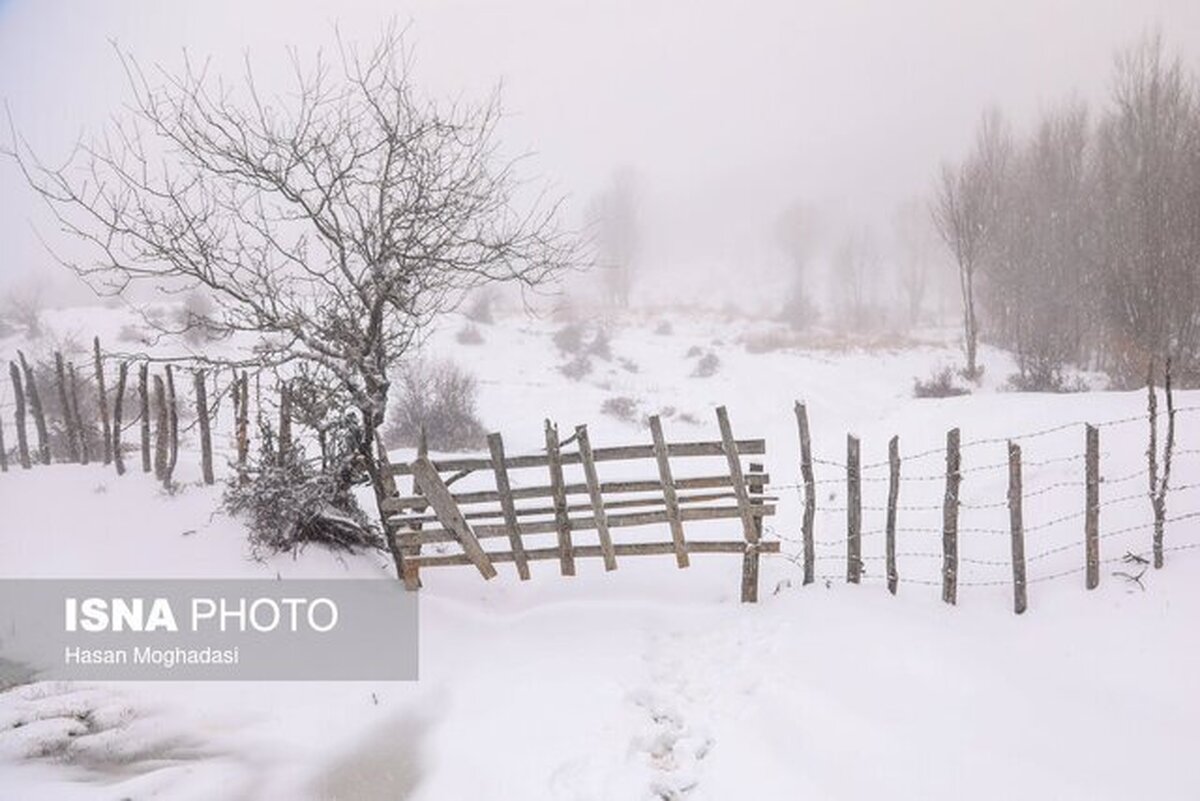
[767,388,1200,614]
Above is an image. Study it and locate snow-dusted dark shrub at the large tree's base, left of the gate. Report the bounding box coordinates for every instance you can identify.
[222,423,383,558]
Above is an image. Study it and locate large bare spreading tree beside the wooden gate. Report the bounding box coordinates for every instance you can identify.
[7,29,575,563]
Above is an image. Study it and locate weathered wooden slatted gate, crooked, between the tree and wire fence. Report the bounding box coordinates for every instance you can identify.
[384,406,779,602]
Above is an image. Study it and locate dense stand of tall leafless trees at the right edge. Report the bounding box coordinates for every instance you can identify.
[932,36,1200,390]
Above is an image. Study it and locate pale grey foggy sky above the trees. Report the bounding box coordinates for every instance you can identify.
[0,0,1200,309]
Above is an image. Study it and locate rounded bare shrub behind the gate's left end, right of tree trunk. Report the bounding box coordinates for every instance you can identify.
[384,360,487,451]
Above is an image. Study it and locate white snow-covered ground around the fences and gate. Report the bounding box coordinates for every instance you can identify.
[0,303,1200,801]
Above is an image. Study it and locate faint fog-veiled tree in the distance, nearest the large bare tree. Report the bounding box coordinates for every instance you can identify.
[587,167,640,308]
